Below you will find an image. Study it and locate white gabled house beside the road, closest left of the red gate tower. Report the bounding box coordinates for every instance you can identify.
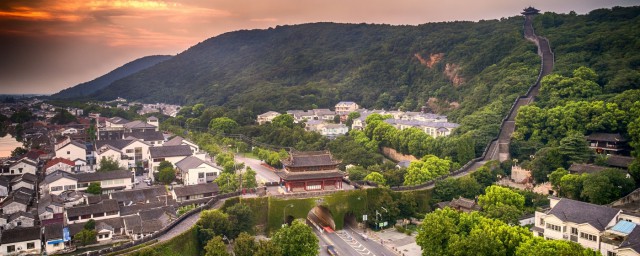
[176,156,222,185]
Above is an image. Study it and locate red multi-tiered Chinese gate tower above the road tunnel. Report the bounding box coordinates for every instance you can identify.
[276,151,344,192]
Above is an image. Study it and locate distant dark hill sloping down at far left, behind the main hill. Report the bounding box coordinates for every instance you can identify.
[51,55,173,99]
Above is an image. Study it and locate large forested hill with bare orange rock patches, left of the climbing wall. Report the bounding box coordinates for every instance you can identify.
[91,16,539,113]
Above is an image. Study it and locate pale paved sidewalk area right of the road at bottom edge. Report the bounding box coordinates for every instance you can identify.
[367,228,422,256]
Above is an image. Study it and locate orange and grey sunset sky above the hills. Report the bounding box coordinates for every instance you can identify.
[0,0,640,94]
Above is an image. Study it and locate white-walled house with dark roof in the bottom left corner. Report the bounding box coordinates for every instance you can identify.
[0,226,42,255]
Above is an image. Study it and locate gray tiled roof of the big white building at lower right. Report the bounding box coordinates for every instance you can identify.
[548,198,620,231]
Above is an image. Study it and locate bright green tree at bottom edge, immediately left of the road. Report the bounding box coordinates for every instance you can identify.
[271,220,318,256]
